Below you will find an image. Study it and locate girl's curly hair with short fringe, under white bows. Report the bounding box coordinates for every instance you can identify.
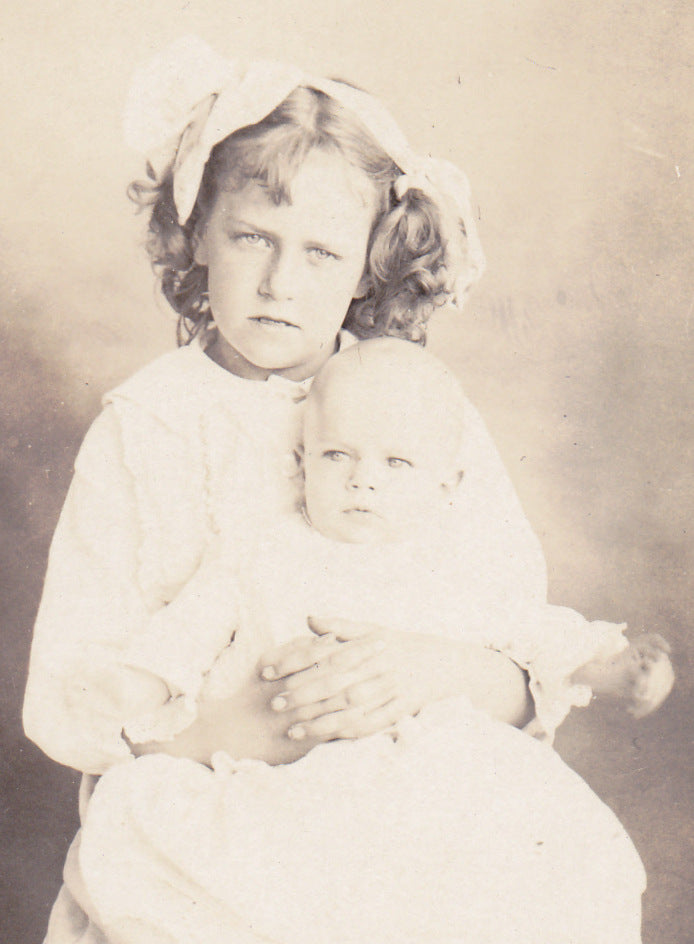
[128,87,460,345]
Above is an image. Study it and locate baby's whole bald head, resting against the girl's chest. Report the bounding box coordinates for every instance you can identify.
[304,338,465,541]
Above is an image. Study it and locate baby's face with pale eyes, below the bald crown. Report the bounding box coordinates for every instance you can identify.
[304,376,460,544]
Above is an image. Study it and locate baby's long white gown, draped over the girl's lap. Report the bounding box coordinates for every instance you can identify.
[80,515,643,944]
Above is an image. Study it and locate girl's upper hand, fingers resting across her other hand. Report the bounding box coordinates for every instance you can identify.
[261,619,474,741]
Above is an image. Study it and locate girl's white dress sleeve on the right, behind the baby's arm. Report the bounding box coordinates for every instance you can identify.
[458,394,628,741]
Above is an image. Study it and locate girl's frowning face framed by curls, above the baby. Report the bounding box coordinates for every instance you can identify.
[195,150,376,380]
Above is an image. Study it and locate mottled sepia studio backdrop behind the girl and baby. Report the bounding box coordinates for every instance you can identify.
[0,0,694,944]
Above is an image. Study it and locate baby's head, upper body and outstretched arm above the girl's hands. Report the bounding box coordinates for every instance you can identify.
[222,338,673,738]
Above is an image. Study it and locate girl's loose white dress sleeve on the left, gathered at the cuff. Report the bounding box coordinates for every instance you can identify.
[24,406,241,774]
